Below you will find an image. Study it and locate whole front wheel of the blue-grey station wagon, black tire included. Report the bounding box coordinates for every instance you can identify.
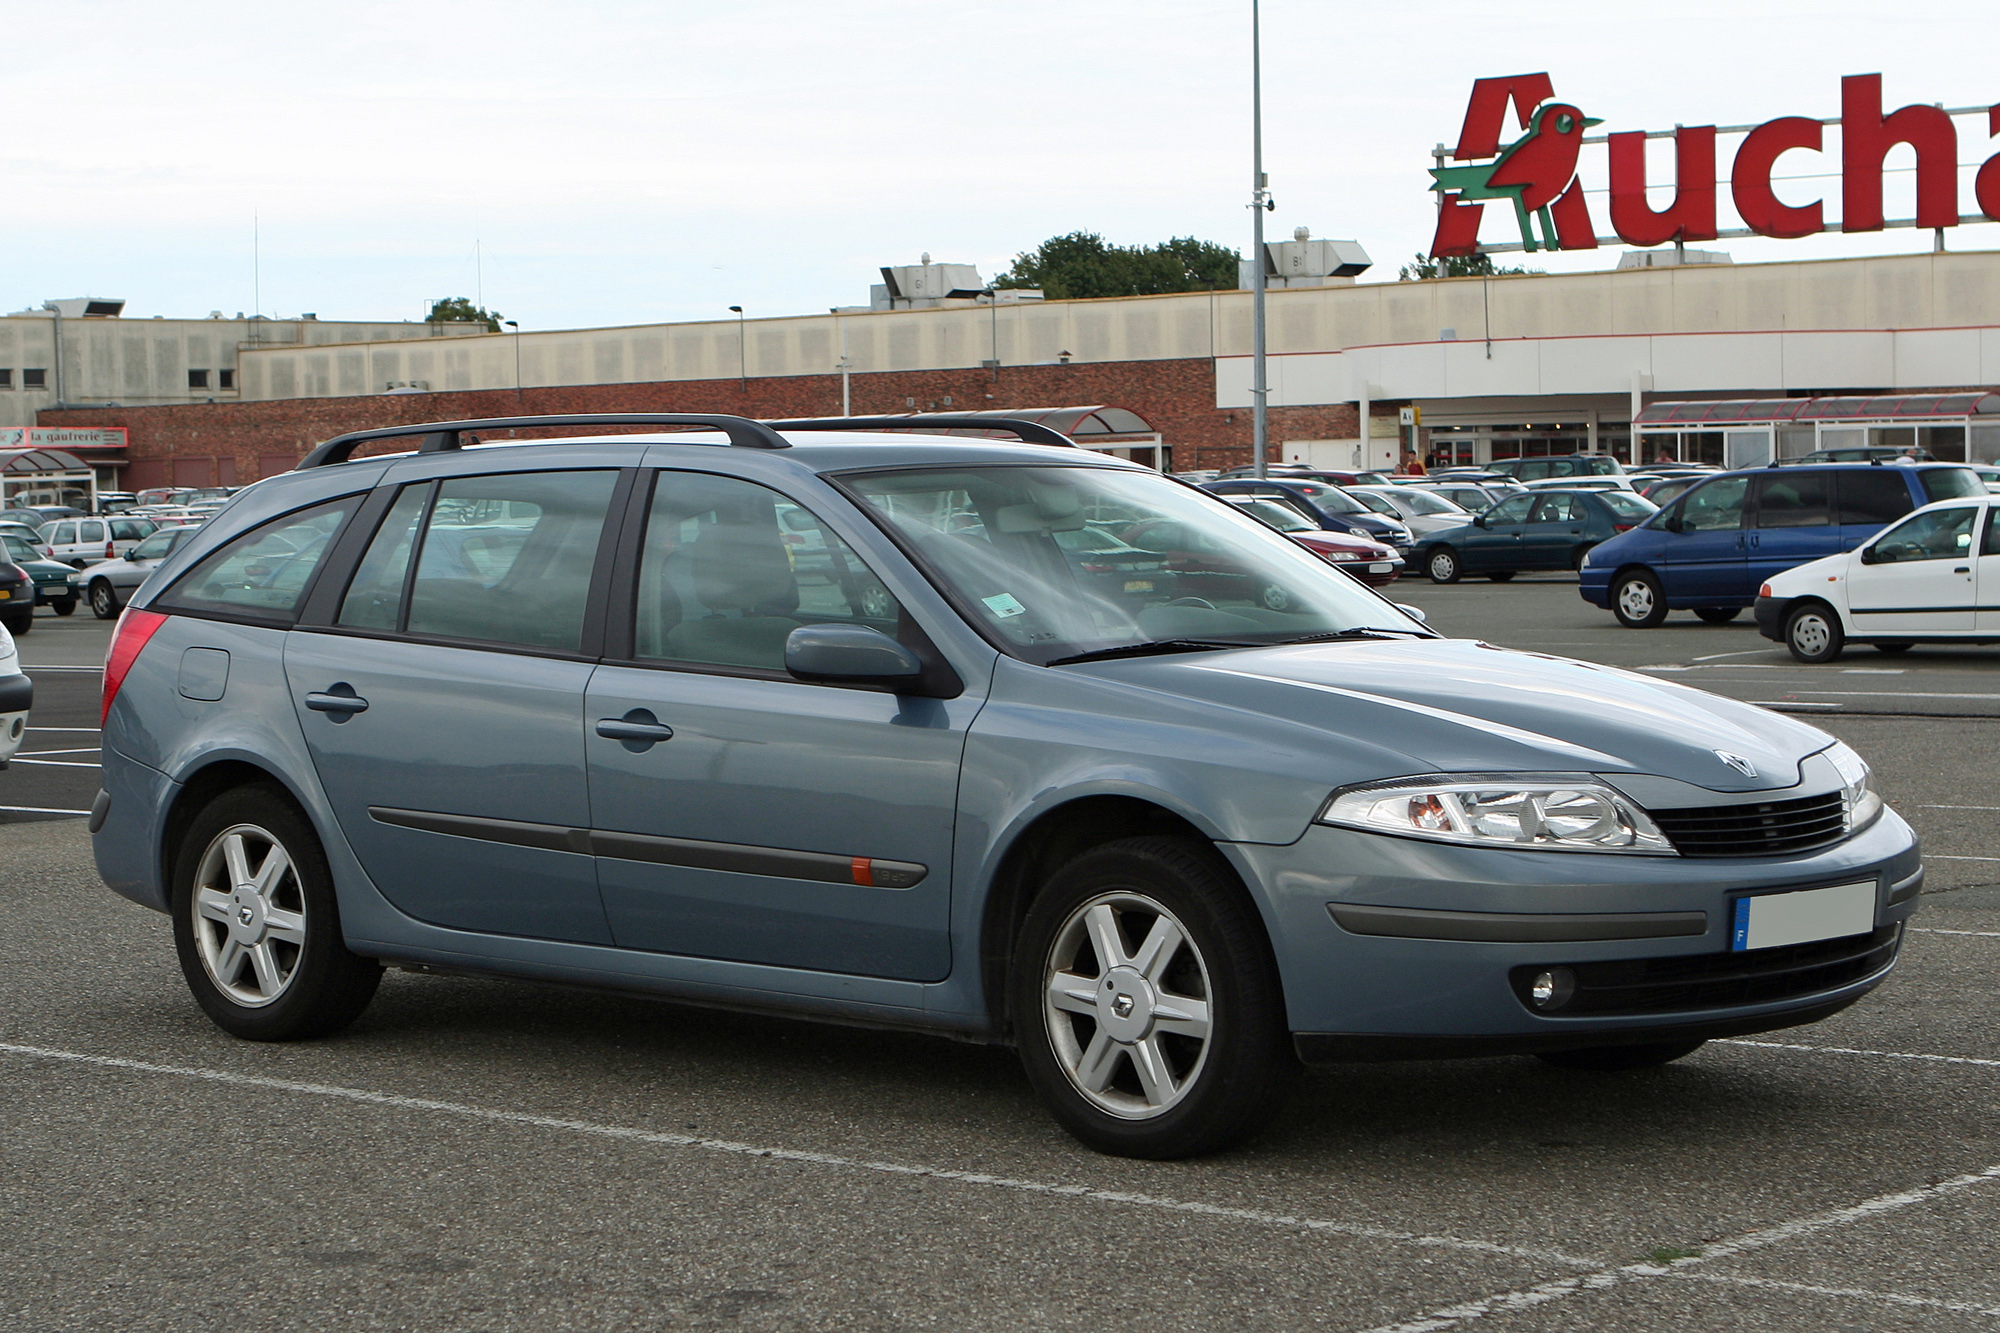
[1010,837,1298,1159]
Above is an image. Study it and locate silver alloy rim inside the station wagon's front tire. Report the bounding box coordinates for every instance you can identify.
[1044,893,1210,1119]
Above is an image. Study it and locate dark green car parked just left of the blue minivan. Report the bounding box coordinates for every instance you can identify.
[1418,490,1654,582]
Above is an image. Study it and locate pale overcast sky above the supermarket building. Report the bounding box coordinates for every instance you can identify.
[0,0,2000,328]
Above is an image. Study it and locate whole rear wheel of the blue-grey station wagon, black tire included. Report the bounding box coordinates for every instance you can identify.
[172,787,382,1041]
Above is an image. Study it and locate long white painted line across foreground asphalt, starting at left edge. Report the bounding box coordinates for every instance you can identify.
[0,1041,1604,1269]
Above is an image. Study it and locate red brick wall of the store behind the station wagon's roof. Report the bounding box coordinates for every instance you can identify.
[38,358,1358,474]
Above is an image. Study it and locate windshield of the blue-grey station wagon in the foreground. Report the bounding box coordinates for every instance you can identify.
[842,466,1426,662]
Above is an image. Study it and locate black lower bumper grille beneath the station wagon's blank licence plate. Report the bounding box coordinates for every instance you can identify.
[1508,925,1902,1019]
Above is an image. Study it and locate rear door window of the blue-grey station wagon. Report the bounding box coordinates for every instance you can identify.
[338,470,618,652]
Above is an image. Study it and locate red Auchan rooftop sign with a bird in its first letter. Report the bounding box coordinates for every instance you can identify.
[1430,74,2000,256]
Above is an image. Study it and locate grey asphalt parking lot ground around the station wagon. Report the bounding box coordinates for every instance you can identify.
[0,578,2000,1333]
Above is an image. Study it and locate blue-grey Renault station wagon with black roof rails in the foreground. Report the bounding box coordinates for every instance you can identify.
[90,414,1922,1157]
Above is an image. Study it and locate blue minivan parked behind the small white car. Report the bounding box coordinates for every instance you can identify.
[1578,462,1986,628]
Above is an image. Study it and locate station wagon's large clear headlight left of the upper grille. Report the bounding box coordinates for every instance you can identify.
[1320,773,1676,857]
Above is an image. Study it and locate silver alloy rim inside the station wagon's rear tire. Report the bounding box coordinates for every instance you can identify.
[194,825,306,1009]
